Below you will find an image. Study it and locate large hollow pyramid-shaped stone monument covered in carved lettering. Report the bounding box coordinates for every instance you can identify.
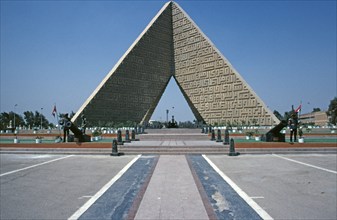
[73,1,279,125]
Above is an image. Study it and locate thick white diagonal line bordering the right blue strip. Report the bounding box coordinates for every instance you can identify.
[202,155,273,219]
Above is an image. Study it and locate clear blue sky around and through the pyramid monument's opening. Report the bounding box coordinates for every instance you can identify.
[0,0,337,123]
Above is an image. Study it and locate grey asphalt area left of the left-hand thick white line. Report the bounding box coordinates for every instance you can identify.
[0,154,134,219]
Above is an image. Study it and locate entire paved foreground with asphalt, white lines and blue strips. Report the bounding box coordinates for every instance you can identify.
[0,154,337,219]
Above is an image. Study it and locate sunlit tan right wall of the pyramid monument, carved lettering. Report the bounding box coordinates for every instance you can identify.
[172,4,279,125]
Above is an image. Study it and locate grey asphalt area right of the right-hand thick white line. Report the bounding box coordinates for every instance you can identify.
[208,154,337,219]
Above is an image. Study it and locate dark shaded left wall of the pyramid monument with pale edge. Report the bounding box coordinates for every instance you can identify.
[72,4,174,124]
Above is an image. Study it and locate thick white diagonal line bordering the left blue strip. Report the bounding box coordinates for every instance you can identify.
[68,154,142,220]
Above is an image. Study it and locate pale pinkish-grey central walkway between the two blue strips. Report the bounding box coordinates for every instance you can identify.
[135,155,208,220]
